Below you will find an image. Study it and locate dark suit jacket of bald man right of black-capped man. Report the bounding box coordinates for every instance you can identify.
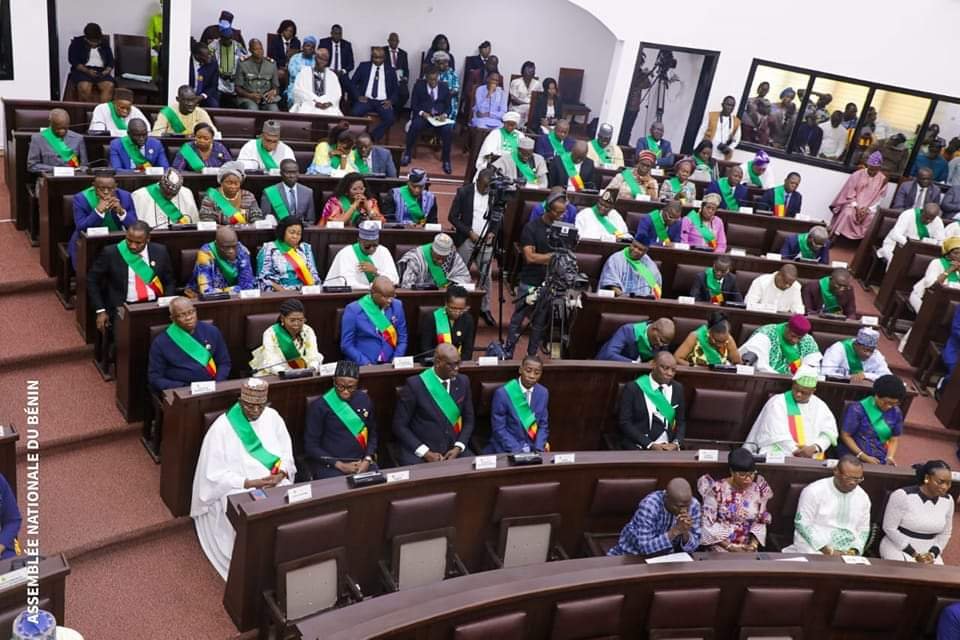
[393,373,473,465]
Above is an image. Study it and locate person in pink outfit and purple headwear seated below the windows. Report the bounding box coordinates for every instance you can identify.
[830,151,888,240]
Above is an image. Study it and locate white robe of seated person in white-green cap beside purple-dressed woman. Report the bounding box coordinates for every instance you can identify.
[746,391,837,456]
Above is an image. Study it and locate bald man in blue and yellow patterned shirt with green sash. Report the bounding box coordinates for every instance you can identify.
[184,226,257,298]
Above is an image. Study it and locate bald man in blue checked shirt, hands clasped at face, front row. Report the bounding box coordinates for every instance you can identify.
[607,478,700,557]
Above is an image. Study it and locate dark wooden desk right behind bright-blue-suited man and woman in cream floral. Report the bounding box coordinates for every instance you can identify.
[115,290,483,422]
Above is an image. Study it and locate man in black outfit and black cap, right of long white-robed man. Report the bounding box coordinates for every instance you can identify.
[303,360,377,479]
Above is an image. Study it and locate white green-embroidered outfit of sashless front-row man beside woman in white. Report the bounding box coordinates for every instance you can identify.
[783,477,870,553]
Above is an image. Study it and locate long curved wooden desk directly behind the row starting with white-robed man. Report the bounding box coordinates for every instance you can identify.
[160,360,896,516]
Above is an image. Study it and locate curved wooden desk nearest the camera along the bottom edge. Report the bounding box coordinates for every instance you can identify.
[296,552,960,640]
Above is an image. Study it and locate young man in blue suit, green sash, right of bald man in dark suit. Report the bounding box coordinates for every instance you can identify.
[484,356,550,454]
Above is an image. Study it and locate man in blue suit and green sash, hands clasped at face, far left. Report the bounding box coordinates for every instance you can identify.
[67,169,137,269]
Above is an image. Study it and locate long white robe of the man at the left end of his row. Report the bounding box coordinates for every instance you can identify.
[190,407,297,580]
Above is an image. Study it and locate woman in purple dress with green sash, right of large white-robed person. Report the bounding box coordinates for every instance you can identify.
[837,374,907,465]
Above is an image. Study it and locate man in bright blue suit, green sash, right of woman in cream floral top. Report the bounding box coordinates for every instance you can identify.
[340,276,407,365]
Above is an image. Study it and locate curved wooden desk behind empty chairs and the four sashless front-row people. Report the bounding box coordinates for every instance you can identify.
[224,451,944,638]
